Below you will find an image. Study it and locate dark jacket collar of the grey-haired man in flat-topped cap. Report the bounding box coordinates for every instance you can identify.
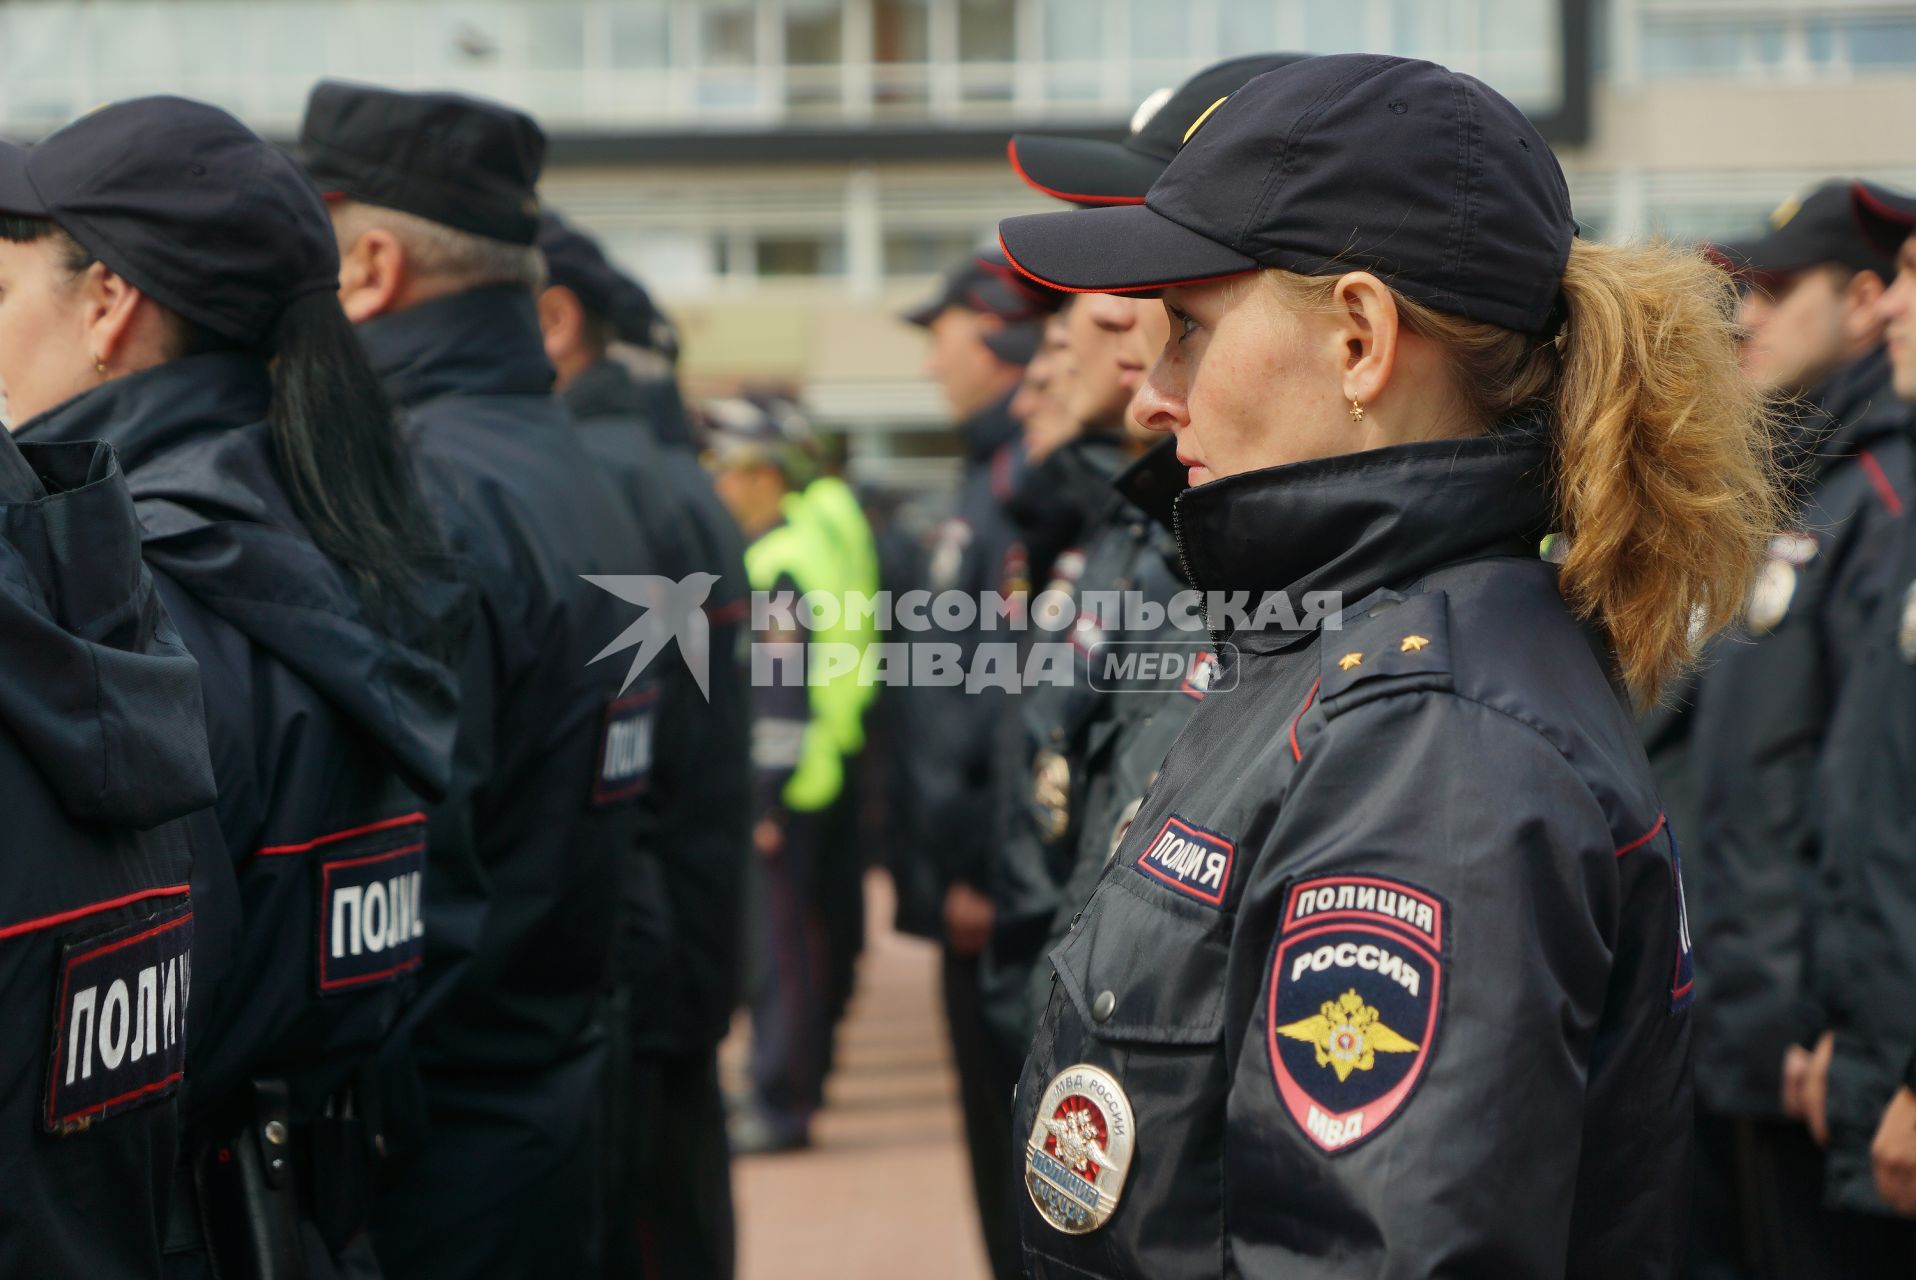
[358,286,554,408]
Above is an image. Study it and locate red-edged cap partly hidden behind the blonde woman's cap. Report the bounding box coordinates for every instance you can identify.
[1006,54,1307,205]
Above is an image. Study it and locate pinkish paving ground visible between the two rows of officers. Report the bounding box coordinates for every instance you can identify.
[724,876,989,1280]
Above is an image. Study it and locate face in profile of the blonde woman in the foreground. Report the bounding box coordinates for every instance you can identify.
[1130,276,1353,485]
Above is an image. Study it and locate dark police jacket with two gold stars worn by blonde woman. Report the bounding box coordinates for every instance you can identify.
[1014,439,1690,1280]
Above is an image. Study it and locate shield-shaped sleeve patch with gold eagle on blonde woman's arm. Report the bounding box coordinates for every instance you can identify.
[1268,876,1448,1152]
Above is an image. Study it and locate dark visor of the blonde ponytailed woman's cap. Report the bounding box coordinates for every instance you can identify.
[998,205,1259,293]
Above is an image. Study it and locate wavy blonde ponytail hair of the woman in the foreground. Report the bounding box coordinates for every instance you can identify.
[1265,240,1784,705]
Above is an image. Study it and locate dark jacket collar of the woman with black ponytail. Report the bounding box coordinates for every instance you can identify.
[17,351,272,475]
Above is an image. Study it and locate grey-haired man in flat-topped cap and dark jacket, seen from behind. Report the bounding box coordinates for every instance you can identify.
[299,82,662,1276]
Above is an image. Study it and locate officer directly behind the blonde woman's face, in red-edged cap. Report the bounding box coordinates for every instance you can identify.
[985,54,1299,1062]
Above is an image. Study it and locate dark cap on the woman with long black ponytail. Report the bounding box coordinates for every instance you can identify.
[0,98,339,345]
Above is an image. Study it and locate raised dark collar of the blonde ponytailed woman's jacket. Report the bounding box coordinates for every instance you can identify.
[1175,429,1554,650]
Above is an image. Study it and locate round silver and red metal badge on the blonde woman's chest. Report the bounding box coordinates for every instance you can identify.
[1025,1062,1138,1236]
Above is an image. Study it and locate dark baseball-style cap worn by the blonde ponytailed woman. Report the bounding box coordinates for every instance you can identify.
[998,54,1577,333]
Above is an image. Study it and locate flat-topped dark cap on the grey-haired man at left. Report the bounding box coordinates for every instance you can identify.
[297,80,546,245]
